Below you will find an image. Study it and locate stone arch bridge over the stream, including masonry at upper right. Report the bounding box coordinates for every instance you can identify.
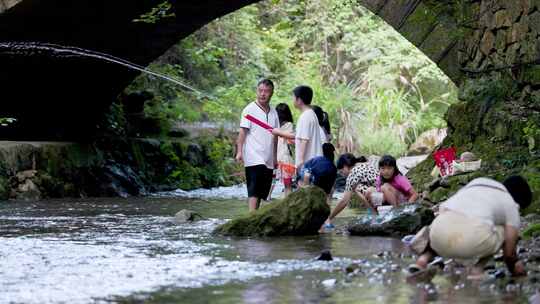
[0,0,540,140]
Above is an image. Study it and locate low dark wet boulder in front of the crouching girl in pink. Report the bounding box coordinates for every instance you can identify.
[347,204,435,237]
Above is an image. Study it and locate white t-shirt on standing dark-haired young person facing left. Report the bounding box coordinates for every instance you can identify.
[295,109,322,168]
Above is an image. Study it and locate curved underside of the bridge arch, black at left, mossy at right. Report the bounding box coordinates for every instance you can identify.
[0,0,459,140]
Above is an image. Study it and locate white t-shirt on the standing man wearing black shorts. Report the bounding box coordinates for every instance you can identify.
[240,102,279,169]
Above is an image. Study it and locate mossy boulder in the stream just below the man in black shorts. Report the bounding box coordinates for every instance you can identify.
[215,187,330,236]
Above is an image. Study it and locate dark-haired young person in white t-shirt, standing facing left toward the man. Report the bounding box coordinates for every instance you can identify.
[293,86,322,170]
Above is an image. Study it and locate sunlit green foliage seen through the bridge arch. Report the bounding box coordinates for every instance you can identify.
[128,0,457,155]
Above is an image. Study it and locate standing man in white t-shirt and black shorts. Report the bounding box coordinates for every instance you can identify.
[236,79,279,211]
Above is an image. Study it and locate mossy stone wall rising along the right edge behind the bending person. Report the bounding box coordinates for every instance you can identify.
[409,0,540,213]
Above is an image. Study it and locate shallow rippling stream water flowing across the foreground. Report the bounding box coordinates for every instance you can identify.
[0,191,530,303]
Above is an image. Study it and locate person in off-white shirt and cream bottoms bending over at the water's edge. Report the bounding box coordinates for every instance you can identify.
[416,176,532,278]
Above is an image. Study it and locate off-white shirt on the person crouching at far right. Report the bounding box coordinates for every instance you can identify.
[442,177,520,228]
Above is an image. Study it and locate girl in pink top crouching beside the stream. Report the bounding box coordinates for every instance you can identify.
[366,155,418,214]
